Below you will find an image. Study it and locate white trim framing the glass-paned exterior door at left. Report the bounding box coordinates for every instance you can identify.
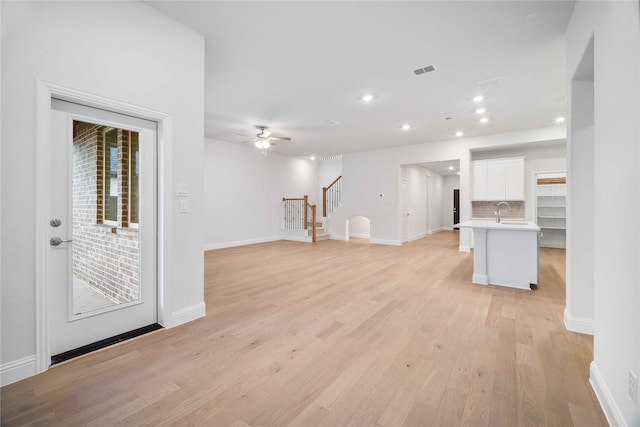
[35,80,173,373]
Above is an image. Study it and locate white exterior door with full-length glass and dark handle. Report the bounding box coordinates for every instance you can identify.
[47,99,157,362]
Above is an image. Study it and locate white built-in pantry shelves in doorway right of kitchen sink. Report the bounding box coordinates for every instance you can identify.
[535,172,567,249]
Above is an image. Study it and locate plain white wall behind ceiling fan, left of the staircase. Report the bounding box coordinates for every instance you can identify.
[204,139,322,249]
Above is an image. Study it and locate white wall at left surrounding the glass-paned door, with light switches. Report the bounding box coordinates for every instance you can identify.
[0,2,204,384]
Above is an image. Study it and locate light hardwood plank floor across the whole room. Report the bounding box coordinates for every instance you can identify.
[1,232,606,427]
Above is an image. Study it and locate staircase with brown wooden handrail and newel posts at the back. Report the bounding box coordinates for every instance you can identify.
[282,176,342,243]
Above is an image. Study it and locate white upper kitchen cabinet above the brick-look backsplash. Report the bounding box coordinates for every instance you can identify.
[472,157,524,201]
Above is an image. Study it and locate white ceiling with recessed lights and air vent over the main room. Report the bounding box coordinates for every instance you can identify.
[149,1,573,156]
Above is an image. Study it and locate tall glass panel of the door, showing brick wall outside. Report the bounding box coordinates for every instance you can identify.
[72,120,140,317]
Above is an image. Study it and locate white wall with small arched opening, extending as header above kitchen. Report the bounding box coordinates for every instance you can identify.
[330,126,566,250]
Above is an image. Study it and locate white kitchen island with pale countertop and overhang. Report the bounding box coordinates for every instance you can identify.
[454,220,540,290]
